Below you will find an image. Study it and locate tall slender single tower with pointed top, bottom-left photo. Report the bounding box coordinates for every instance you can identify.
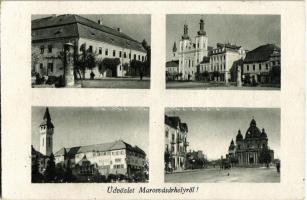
[39,107,54,156]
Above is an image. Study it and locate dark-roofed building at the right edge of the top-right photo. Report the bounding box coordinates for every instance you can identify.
[243,44,280,83]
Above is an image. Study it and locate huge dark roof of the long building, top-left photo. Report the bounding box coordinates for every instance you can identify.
[32,15,146,53]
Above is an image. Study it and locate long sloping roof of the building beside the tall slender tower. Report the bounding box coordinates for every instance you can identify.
[55,140,146,156]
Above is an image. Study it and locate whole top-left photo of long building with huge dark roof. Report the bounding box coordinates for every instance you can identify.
[31,14,151,89]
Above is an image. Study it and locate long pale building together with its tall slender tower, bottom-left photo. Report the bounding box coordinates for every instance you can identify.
[32,108,146,177]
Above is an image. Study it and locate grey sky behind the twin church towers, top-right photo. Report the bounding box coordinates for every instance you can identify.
[166,15,280,60]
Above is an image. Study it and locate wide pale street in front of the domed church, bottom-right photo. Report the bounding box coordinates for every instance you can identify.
[165,167,280,183]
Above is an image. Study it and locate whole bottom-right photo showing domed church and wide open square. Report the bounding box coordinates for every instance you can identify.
[164,107,282,183]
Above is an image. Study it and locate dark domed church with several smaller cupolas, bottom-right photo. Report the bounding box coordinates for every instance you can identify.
[226,119,274,166]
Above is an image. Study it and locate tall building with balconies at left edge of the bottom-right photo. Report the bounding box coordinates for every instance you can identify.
[165,115,189,170]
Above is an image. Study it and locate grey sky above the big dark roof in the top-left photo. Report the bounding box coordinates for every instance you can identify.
[32,14,151,44]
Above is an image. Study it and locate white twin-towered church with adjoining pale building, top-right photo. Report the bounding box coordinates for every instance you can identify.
[174,19,245,82]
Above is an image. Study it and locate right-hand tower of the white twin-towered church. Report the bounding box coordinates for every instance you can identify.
[195,19,208,63]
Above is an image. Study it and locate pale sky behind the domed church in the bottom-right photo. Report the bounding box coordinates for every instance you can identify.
[166,108,280,160]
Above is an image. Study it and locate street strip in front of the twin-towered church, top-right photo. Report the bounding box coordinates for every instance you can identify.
[166,81,280,90]
